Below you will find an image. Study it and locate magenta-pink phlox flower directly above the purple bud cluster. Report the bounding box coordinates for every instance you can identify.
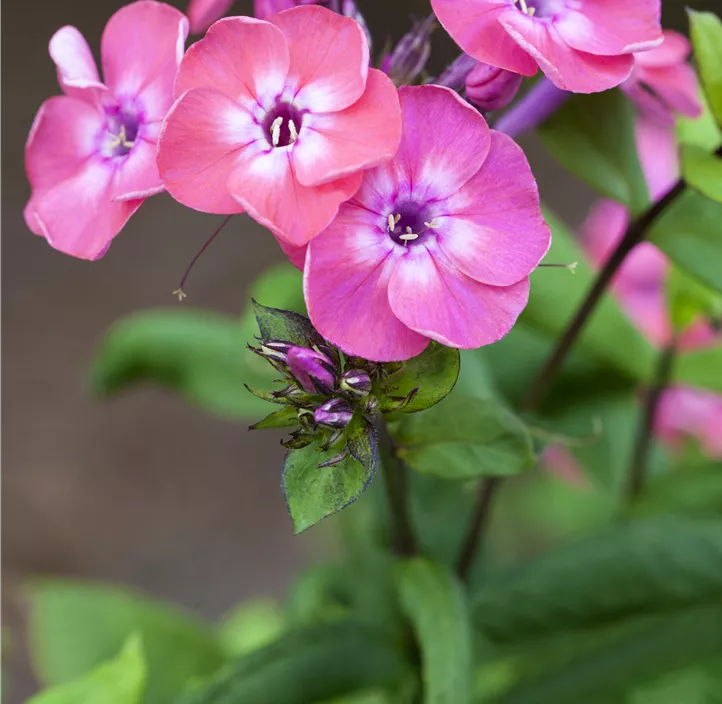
[304,86,550,361]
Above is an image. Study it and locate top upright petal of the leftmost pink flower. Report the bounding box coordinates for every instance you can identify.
[100,0,188,122]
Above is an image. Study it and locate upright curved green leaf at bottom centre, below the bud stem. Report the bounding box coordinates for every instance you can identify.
[396,557,472,704]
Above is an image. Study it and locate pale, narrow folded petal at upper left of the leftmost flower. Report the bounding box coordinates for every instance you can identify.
[48,25,113,102]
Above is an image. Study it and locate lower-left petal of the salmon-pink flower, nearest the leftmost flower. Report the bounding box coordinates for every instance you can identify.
[158,88,258,213]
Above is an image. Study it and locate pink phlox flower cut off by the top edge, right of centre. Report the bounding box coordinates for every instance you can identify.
[431,0,662,93]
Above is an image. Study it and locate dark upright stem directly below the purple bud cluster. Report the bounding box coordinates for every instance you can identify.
[376,418,416,557]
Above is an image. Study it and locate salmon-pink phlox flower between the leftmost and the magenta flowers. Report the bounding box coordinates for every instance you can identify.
[158,5,401,246]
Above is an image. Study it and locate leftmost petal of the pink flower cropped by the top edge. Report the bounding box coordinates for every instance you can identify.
[431,0,537,76]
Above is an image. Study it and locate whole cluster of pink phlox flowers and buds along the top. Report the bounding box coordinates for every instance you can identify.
[25,0,680,362]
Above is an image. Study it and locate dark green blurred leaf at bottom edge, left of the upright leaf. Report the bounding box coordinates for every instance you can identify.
[179,621,407,704]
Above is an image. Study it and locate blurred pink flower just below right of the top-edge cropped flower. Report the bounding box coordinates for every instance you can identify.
[621,30,702,125]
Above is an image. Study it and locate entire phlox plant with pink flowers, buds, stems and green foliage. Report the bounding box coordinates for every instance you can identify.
[15,0,722,704]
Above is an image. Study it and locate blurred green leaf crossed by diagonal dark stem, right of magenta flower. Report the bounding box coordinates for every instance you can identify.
[520,209,656,380]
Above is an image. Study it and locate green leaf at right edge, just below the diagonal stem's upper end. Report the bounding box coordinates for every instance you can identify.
[648,189,722,291]
